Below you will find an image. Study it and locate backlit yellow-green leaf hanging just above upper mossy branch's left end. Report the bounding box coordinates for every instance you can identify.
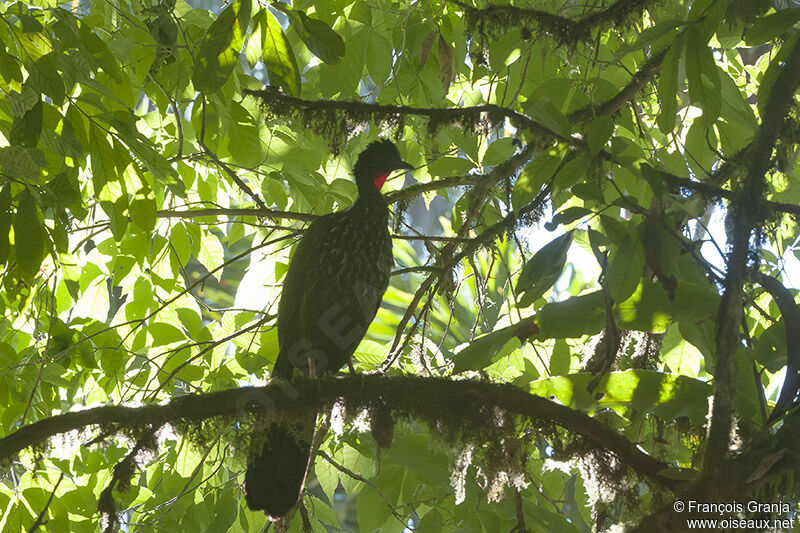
[254,9,300,96]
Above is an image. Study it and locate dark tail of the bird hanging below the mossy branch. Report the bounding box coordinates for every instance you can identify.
[244,413,317,519]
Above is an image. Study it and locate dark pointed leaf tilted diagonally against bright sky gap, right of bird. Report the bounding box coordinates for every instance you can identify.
[516,231,572,307]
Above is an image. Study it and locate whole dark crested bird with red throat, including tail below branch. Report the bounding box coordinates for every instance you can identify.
[245,140,412,519]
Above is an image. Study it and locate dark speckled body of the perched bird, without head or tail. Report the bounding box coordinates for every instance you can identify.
[273,185,393,378]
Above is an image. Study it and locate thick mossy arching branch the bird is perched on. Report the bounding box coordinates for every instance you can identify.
[0,375,678,488]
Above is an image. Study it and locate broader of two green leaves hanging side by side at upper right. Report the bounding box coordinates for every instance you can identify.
[685,27,720,124]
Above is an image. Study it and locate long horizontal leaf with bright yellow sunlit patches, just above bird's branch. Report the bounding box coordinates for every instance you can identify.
[530,369,711,423]
